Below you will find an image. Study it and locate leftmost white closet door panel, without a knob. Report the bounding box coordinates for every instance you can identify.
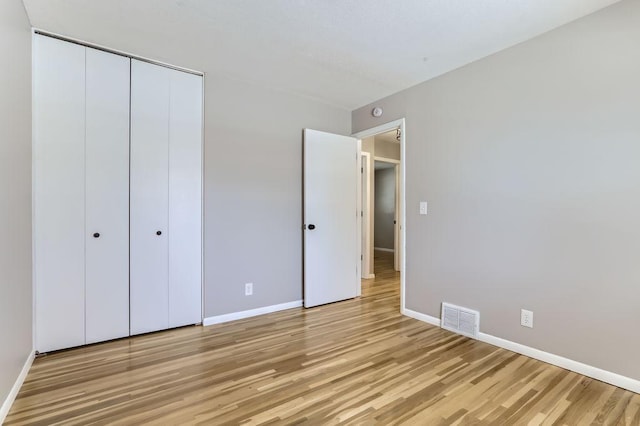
[33,35,85,352]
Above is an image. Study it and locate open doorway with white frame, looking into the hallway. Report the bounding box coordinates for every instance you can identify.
[353,119,405,311]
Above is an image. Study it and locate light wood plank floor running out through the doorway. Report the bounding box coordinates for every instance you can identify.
[6,253,640,425]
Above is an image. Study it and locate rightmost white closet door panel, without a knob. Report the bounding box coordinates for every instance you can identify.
[169,70,202,327]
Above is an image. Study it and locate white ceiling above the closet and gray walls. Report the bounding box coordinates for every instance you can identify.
[24,0,619,109]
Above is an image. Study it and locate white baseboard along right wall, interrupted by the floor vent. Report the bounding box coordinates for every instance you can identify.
[402,308,640,393]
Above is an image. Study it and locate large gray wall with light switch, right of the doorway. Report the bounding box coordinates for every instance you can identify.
[353,0,640,379]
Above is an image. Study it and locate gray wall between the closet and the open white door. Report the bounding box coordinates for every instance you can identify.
[205,78,351,316]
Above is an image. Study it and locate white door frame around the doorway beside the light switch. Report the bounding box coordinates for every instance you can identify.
[351,118,407,312]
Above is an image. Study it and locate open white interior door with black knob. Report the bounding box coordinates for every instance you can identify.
[303,129,360,308]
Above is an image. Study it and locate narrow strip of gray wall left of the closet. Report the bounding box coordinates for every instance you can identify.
[0,0,33,405]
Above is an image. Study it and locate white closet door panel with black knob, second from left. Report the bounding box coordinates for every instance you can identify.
[85,48,130,343]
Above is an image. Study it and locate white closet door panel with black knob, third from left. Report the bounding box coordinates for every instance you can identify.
[130,60,170,334]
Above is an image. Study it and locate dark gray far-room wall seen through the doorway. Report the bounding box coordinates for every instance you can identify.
[373,167,396,250]
